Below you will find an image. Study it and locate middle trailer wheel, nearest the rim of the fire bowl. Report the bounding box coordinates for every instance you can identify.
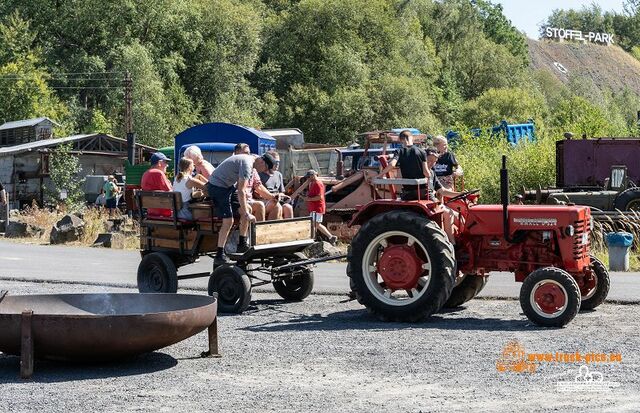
[209,264,251,314]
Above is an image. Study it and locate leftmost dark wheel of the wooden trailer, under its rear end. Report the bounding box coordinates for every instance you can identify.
[138,252,178,293]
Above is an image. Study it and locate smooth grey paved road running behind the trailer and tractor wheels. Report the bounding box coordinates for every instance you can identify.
[0,240,640,302]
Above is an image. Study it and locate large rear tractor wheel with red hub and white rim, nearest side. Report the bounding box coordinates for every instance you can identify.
[347,210,455,322]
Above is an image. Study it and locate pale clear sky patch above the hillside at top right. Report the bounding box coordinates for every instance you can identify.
[492,0,623,39]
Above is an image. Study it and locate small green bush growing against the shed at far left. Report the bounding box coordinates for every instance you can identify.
[49,143,84,211]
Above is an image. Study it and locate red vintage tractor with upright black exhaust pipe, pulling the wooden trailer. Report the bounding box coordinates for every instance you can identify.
[347,157,610,327]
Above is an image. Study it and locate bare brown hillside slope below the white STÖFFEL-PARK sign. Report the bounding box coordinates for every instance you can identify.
[527,39,640,94]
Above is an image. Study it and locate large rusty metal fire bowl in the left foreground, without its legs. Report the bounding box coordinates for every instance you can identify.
[0,294,218,360]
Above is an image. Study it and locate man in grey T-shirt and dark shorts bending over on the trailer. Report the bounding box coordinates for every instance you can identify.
[207,153,268,268]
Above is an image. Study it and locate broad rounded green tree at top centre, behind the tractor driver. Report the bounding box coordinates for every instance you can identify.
[253,0,438,144]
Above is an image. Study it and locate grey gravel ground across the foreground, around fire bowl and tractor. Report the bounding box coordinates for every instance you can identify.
[0,282,640,412]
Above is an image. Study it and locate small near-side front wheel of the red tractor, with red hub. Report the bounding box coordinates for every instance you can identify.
[520,267,580,327]
